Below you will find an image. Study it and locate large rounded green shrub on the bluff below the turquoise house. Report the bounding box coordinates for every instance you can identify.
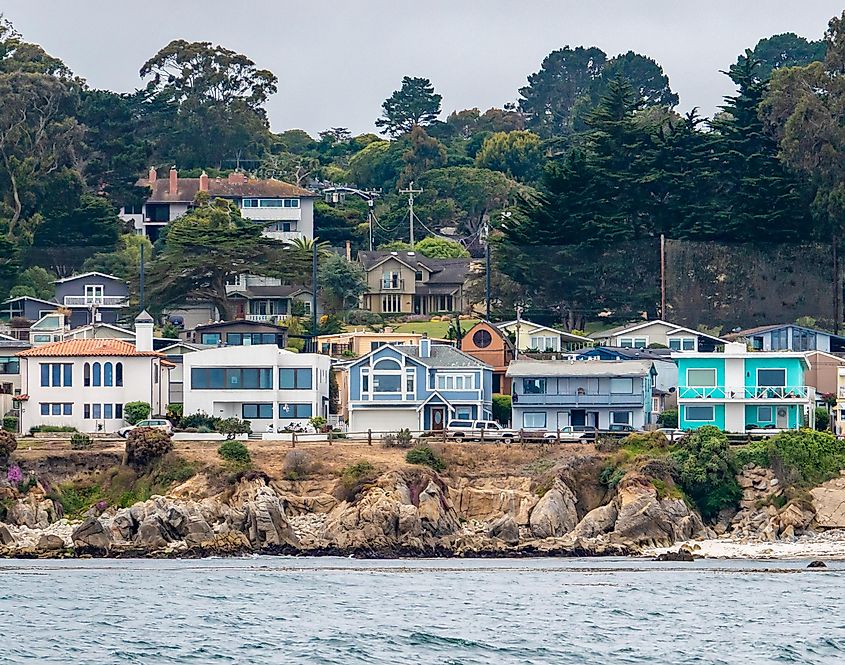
[672,425,742,518]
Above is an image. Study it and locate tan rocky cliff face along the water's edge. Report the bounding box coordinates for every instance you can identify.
[0,446,707,557]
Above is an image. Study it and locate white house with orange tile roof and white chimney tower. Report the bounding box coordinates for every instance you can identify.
[17,312,172,432]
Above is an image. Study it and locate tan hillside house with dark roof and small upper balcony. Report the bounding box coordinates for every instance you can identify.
[358,251,471,314]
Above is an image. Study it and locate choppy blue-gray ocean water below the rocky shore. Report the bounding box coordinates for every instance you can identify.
[0,557,845,665]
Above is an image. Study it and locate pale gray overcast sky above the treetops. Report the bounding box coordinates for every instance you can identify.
[0,0,843,135]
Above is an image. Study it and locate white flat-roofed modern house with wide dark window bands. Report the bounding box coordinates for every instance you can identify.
[182,344,331,432]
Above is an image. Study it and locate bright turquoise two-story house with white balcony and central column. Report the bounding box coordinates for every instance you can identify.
[673,342,815,433]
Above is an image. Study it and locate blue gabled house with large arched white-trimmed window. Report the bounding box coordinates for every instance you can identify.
[349,337,493,432]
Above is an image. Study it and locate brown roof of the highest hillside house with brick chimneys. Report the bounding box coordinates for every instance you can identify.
[145,176,319,203]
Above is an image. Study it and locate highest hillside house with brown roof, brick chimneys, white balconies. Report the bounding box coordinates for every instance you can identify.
[121,167,319,242]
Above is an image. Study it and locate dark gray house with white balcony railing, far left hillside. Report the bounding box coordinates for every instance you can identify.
[54,272,129,328]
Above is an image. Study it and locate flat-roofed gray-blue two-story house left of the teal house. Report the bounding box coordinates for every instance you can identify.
[507,359,657,431]
